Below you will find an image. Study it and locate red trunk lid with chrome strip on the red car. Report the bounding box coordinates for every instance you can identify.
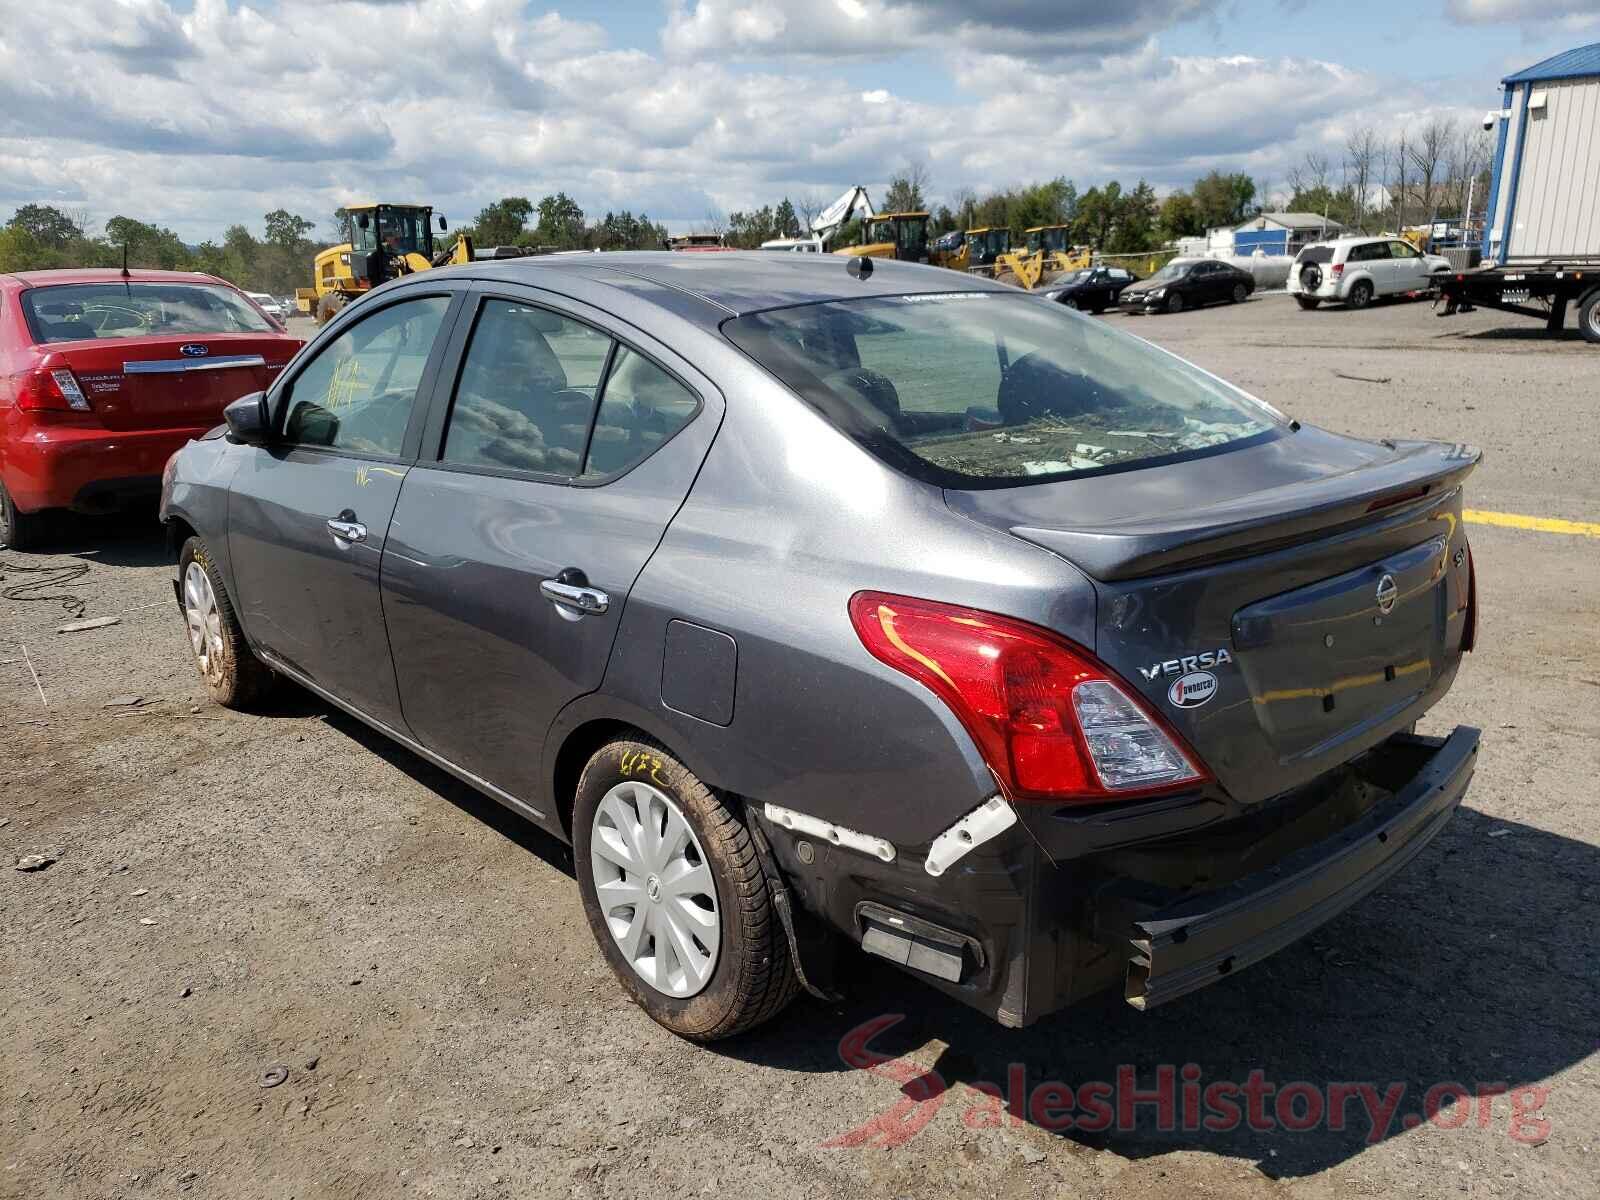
[43,333,301,430]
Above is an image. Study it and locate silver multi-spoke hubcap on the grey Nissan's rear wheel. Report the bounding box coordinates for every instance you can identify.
[589,779,722,998]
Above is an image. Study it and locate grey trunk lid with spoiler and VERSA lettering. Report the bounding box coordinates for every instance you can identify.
[946,429,1478,803]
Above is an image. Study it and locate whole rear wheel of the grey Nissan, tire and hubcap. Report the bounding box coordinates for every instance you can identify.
[573,738,800,1042]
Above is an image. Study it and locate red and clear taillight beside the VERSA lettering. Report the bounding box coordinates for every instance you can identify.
[850,592,1206,803]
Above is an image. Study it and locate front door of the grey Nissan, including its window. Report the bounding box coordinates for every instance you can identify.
[229,283,466,728]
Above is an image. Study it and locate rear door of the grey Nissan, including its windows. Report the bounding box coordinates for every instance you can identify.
[382,285,722,798]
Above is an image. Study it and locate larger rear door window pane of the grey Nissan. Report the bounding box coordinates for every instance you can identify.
[445,299,611,475]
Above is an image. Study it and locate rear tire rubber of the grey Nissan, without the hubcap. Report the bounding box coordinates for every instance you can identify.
[573,736,800,1042]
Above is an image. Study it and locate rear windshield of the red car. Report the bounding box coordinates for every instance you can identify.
[22,283,275,342]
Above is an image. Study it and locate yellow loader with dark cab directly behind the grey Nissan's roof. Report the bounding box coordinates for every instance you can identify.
[294,203,472,325]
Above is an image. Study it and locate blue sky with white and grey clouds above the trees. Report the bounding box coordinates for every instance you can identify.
[0,0,1600,242]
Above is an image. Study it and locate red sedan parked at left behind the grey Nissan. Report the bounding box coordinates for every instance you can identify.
[0,269,301,549]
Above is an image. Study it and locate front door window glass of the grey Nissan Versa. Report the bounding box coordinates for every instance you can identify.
[283,296,450,458]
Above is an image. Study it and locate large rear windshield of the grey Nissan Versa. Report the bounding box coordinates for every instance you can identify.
[723,291,1283,488]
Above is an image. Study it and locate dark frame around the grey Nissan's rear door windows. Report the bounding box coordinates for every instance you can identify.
[418,280,709,488]
